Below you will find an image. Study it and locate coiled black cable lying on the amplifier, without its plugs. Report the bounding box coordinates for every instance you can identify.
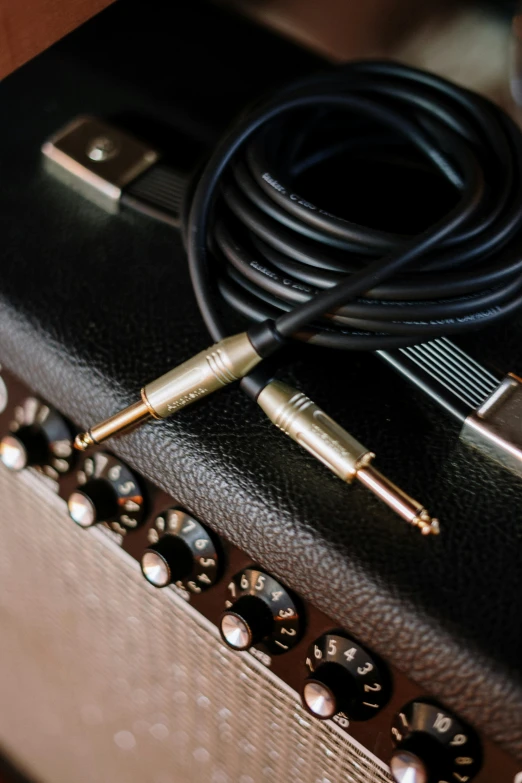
[184,61,522,353]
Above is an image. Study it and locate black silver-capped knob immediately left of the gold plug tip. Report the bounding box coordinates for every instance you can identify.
[0,397,75,479]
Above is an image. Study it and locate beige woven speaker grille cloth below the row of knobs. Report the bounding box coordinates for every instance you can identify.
[0,468,391,783]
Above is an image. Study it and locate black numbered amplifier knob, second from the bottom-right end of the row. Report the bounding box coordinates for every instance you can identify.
[302,633,390,725]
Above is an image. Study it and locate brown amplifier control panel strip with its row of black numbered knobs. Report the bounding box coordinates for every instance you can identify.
[0,372,522,783]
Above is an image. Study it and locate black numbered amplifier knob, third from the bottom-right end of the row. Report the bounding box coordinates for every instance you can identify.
[220,568,302,655]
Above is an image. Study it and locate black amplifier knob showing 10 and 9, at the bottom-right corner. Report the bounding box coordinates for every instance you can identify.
[390,700,482,783]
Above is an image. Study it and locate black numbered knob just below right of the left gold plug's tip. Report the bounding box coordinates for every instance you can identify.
[67,452,145,535]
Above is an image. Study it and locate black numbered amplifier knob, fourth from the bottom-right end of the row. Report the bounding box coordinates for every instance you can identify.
[141,508,220,593]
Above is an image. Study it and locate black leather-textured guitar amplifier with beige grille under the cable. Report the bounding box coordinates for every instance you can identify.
[0,2,522,783]
